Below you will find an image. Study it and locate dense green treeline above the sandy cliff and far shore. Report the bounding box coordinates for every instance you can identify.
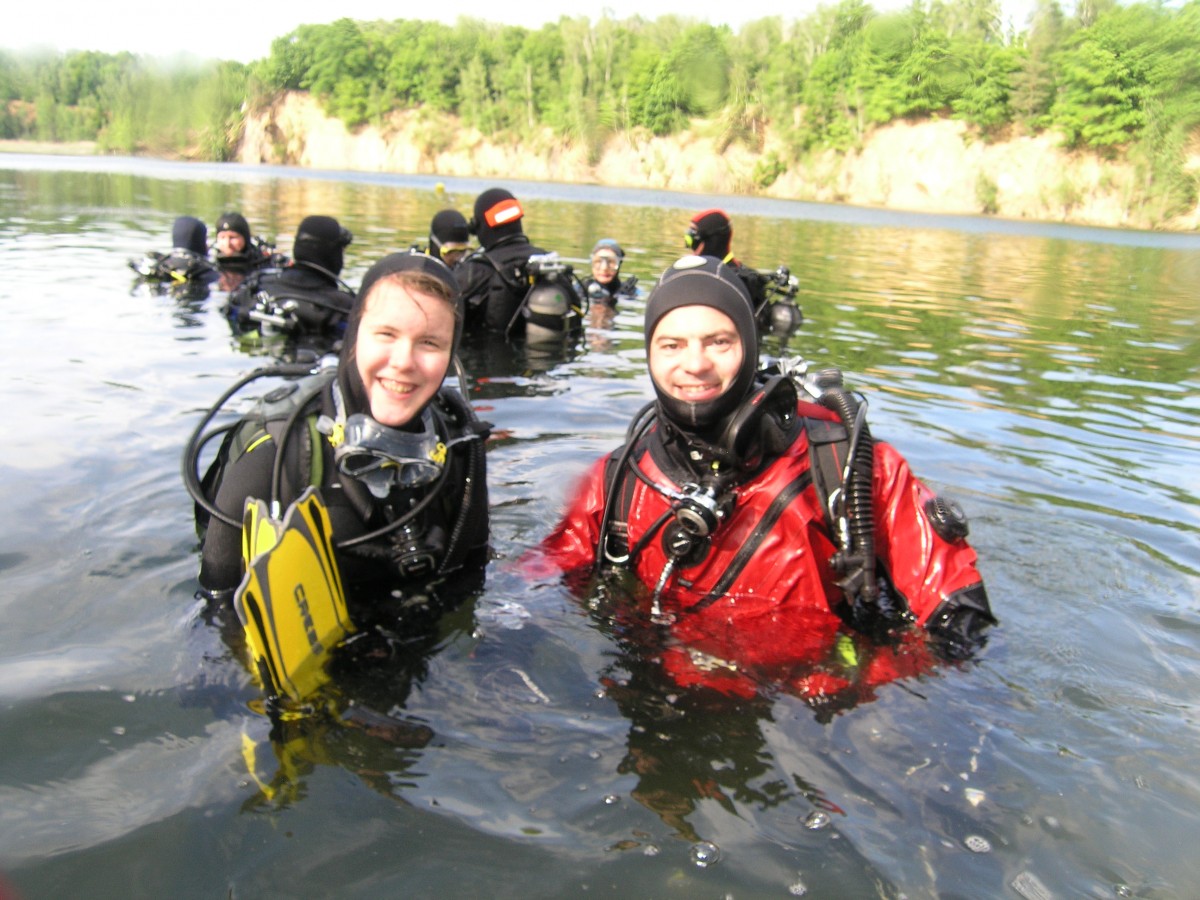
[0,0,1200,215]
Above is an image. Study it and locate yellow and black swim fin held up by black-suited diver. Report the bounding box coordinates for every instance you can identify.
[233,487,354,701]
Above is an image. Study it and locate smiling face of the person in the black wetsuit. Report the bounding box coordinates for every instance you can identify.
[354,280,455,428]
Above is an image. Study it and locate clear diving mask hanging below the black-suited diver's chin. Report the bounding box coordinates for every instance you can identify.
[334,409,446,499]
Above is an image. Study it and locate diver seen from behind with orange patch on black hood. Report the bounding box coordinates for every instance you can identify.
[456,187,584,341]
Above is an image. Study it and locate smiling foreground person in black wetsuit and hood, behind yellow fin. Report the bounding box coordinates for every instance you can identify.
[184,247,490,613]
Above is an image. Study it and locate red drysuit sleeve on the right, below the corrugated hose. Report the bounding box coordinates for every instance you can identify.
[874,442,983,625]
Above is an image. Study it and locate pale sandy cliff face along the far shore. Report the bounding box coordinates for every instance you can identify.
[239,94,1200,230]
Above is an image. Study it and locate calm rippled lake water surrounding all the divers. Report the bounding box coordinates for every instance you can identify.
[0,156,1200,900]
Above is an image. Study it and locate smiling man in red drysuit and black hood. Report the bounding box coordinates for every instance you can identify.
[527,256,995,692]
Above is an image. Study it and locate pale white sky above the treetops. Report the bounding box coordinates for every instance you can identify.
[0,0,1032,62]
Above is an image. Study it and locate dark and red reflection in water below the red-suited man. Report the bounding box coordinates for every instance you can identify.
[585,577,950,841]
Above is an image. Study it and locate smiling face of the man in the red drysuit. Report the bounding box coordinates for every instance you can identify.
[649,305,744,403]
